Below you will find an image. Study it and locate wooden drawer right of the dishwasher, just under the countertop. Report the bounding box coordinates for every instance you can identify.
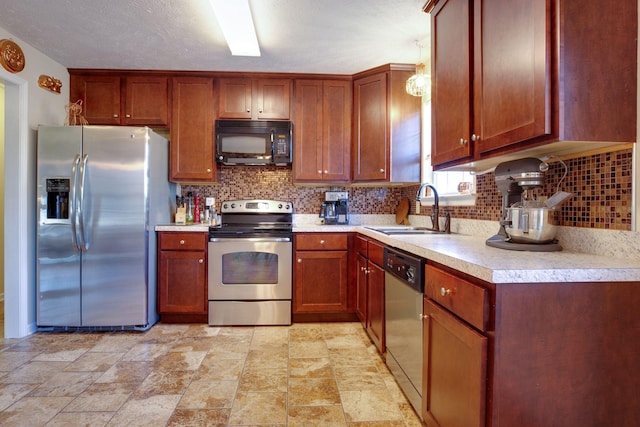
[424,265,489,331]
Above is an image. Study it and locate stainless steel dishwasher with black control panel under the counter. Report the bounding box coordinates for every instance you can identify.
[384,248,425,418]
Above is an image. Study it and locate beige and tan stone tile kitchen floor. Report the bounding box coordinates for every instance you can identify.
[0,323,422,427]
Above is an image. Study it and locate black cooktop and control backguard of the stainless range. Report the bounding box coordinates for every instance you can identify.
[209,200,293,239]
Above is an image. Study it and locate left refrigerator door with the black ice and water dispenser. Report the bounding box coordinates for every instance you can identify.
[36,127,82,326]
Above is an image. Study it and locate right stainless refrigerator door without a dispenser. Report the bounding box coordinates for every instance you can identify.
[80,126,148,326]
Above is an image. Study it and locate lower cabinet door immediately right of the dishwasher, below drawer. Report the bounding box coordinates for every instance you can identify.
[422,300,487,427]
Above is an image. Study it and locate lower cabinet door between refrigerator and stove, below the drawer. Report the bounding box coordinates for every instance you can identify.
[158,251,207,314]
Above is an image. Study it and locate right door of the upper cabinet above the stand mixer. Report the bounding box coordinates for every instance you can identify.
[476,0,551,153]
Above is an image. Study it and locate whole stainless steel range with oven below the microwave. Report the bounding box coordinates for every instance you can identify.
[208,200,293,326]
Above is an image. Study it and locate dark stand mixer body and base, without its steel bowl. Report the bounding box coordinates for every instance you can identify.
[486,157,562,252]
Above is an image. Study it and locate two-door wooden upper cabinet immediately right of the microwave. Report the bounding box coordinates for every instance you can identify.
[293,80,352,182]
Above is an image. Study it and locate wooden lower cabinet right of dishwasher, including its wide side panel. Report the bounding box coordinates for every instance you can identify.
[422,263,640,427]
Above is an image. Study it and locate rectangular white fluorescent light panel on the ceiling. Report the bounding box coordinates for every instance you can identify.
[209,0,260,56]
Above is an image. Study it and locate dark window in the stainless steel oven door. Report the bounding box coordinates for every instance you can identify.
[222,252,278,285]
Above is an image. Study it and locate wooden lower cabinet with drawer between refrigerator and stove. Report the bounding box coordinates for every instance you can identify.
[158,232,207,322]
